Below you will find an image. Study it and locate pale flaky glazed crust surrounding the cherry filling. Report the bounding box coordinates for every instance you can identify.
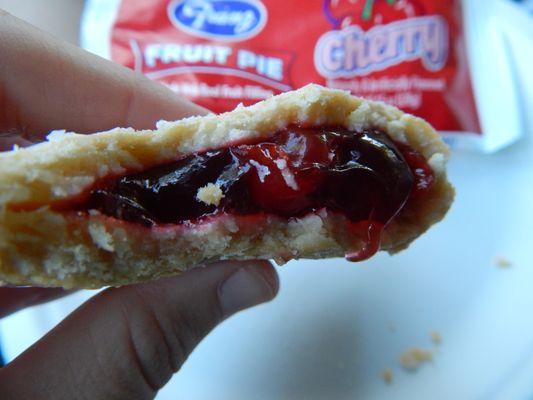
[0,85,454,288]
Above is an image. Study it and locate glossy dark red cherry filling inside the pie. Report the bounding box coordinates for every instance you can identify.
[88,126,433,260]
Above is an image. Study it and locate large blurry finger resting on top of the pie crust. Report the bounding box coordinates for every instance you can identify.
[0,10,206,140]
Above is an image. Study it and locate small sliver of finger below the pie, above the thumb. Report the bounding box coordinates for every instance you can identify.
[0,287,73,318]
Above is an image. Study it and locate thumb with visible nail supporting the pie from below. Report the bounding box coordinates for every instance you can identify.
[0,261,278,399]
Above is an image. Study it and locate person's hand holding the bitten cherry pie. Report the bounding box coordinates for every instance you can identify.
[0,11,278,399]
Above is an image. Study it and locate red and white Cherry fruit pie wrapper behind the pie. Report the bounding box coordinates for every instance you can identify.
[82,0,520,152]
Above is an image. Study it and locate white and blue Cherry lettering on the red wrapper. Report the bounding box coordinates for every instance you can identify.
[314,16,449,78]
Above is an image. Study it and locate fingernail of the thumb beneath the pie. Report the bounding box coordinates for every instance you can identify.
[218,265,275,316]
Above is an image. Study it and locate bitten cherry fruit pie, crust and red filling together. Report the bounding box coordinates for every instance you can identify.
[0,85,454,288]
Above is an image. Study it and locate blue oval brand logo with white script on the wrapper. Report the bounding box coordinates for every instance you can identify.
[168,0,267,41]
